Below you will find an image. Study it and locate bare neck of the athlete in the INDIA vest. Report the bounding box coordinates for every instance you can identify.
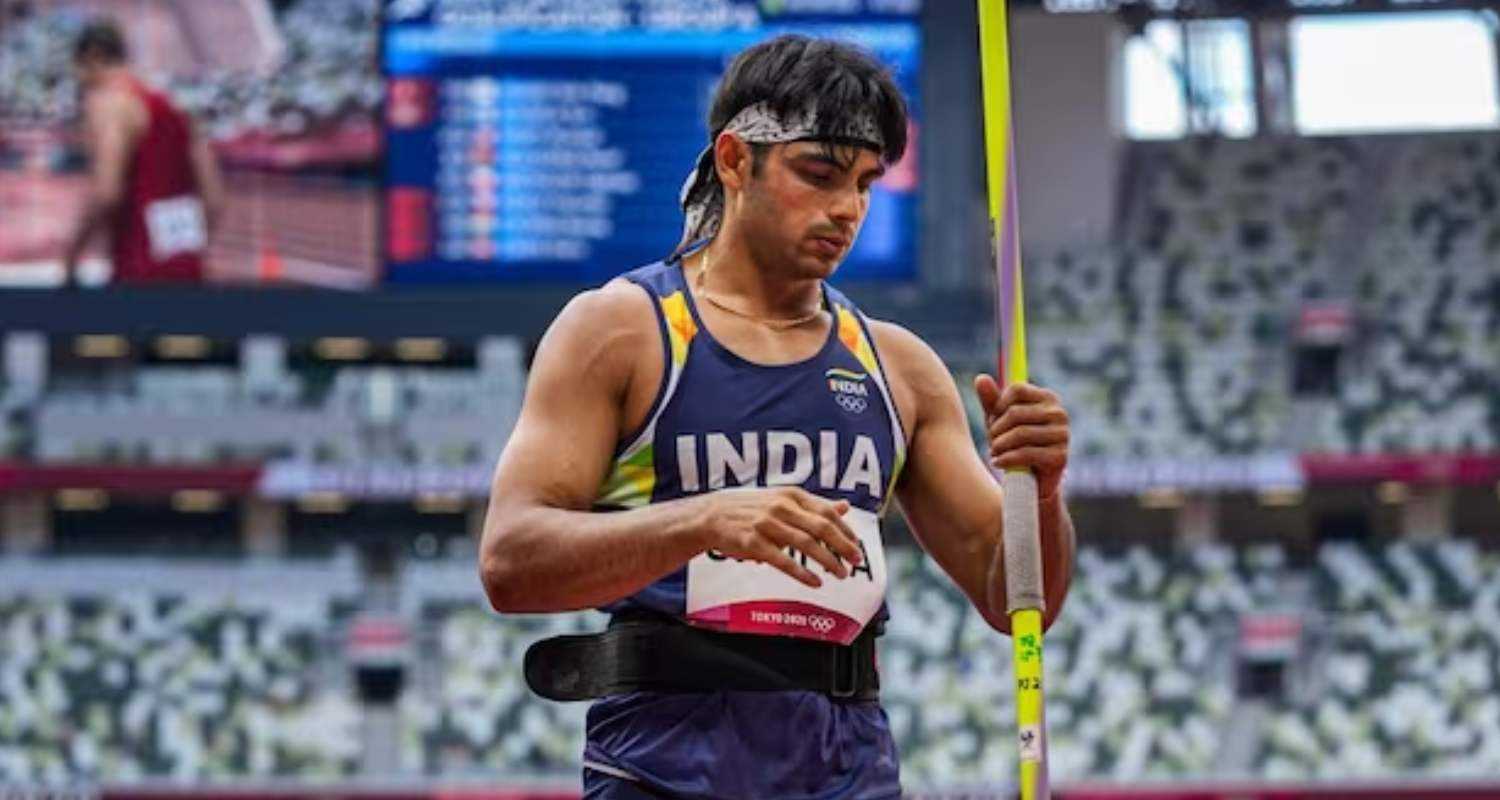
[684,236,824,320]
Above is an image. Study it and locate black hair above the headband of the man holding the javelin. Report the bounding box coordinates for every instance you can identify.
[708,35,906,164]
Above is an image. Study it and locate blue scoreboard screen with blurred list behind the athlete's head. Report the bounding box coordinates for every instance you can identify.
[381,0,921,284]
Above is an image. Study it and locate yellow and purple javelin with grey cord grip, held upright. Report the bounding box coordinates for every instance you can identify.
[978,0,1052,800]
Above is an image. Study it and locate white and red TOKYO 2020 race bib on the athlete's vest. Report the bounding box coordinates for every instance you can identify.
[687,509,887,644]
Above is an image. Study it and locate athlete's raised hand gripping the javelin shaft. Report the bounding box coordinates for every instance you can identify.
[974,375,1070,500]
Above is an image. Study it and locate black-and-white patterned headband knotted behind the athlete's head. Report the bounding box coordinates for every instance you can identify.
[672,102,885,260]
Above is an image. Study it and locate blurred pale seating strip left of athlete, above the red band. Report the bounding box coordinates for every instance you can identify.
[26,353,524,467]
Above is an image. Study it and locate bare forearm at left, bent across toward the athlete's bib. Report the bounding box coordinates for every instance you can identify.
[480,500,704,612]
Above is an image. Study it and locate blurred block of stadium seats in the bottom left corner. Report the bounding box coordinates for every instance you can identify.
[0,561,359,786]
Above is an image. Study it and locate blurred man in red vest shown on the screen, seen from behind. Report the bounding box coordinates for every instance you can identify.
[63,21,224,284]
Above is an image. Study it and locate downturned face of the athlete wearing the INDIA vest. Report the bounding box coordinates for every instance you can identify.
[726,141,885,278]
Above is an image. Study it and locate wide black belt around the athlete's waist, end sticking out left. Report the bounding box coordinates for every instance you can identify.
[525,611,881,701]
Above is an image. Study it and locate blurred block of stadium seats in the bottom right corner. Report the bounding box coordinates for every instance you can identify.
[1257,540,1500,779]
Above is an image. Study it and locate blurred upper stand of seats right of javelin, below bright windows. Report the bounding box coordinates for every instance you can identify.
[1028,134,1500,458]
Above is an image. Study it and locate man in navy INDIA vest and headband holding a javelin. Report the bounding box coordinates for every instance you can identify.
[480,36,1074,800]
